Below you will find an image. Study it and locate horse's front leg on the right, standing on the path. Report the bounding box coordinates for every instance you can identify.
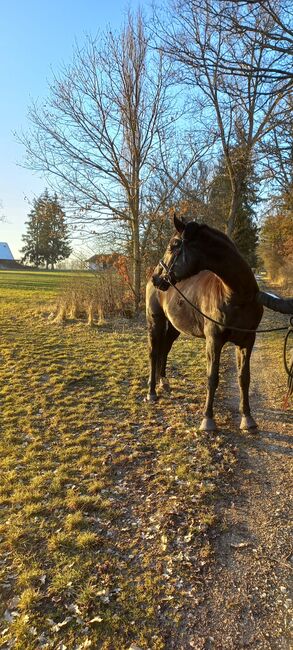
[236,336,257,431]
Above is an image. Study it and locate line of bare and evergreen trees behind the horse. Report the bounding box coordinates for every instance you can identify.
[21,0,293,308]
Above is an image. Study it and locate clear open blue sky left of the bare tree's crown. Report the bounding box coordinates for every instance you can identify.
[0,0,138,258]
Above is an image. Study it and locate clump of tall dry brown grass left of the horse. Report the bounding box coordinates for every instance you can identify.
[54,270,133,326]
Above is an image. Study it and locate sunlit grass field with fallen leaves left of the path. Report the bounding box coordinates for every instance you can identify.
[0,272,278,650]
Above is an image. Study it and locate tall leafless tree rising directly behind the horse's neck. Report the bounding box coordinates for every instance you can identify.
[155,0,289,236]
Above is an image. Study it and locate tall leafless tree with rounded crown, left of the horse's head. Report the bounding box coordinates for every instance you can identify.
[22,13,196,308]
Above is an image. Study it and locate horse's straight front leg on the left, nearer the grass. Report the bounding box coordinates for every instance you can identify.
[200,336,223,431]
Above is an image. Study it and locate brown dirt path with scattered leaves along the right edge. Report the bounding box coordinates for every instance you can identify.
[184,318,293,650]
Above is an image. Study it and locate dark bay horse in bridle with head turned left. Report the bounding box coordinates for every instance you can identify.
[146,216,293,431]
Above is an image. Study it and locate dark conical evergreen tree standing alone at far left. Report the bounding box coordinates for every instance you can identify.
[21,190,72,269]
